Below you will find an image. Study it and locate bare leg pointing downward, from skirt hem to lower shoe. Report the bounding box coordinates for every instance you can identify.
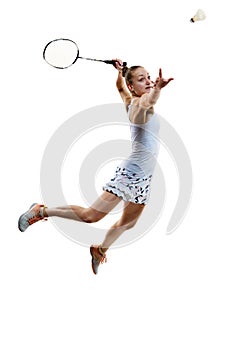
[101,202,145,253]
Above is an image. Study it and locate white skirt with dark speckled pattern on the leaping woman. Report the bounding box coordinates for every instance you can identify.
[103,167,152,204]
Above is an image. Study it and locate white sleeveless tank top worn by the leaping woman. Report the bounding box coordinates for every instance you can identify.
[121,113,160,178]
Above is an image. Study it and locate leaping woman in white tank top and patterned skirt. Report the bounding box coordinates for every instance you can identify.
[18,59,173,274]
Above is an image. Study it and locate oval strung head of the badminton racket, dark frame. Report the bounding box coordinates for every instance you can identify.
[43,38,79,69]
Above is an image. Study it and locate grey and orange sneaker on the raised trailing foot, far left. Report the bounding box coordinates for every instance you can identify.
[18,203,46,232]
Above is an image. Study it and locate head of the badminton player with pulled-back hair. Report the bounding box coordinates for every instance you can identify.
[128,67,153,97]
